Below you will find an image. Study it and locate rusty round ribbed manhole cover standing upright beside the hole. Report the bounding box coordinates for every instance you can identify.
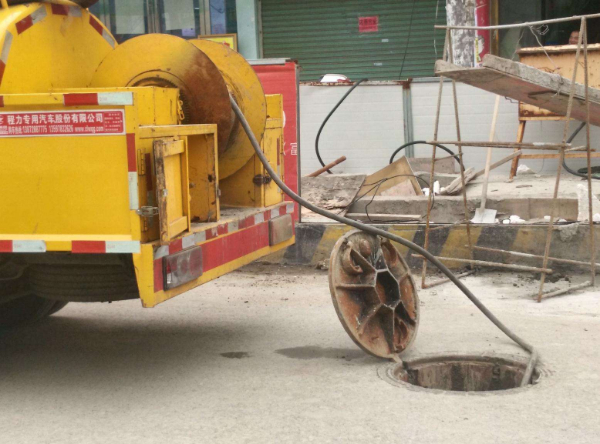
[329,231,419,358]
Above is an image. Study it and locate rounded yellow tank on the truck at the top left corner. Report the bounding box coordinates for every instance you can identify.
[0,2,116,94]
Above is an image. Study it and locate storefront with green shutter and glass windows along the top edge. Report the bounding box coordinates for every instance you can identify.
[86,0,600,81]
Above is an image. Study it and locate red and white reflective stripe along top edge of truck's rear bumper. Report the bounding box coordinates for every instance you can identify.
[154,203,294,260]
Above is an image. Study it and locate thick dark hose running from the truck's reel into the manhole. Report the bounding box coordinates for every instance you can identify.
[230,97,538,387]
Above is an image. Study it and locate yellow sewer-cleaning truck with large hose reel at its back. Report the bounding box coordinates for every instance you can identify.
[0,0,294,330]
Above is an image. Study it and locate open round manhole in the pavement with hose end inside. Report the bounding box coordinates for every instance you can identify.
[379,356,544,392]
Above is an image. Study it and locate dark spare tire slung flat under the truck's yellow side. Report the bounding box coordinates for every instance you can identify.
[29,264,139,302]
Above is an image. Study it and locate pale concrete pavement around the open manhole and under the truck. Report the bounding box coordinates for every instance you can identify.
[0,265,600,444]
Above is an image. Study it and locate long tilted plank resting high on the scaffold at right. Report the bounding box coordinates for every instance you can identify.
[435,54,600,126]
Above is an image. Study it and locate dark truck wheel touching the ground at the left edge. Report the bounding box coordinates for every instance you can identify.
[0,294,56,331]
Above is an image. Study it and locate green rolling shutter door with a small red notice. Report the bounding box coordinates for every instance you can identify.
[261,0,446,81]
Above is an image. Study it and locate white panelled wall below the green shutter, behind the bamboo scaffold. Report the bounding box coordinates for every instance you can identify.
[300,79,600,175]
